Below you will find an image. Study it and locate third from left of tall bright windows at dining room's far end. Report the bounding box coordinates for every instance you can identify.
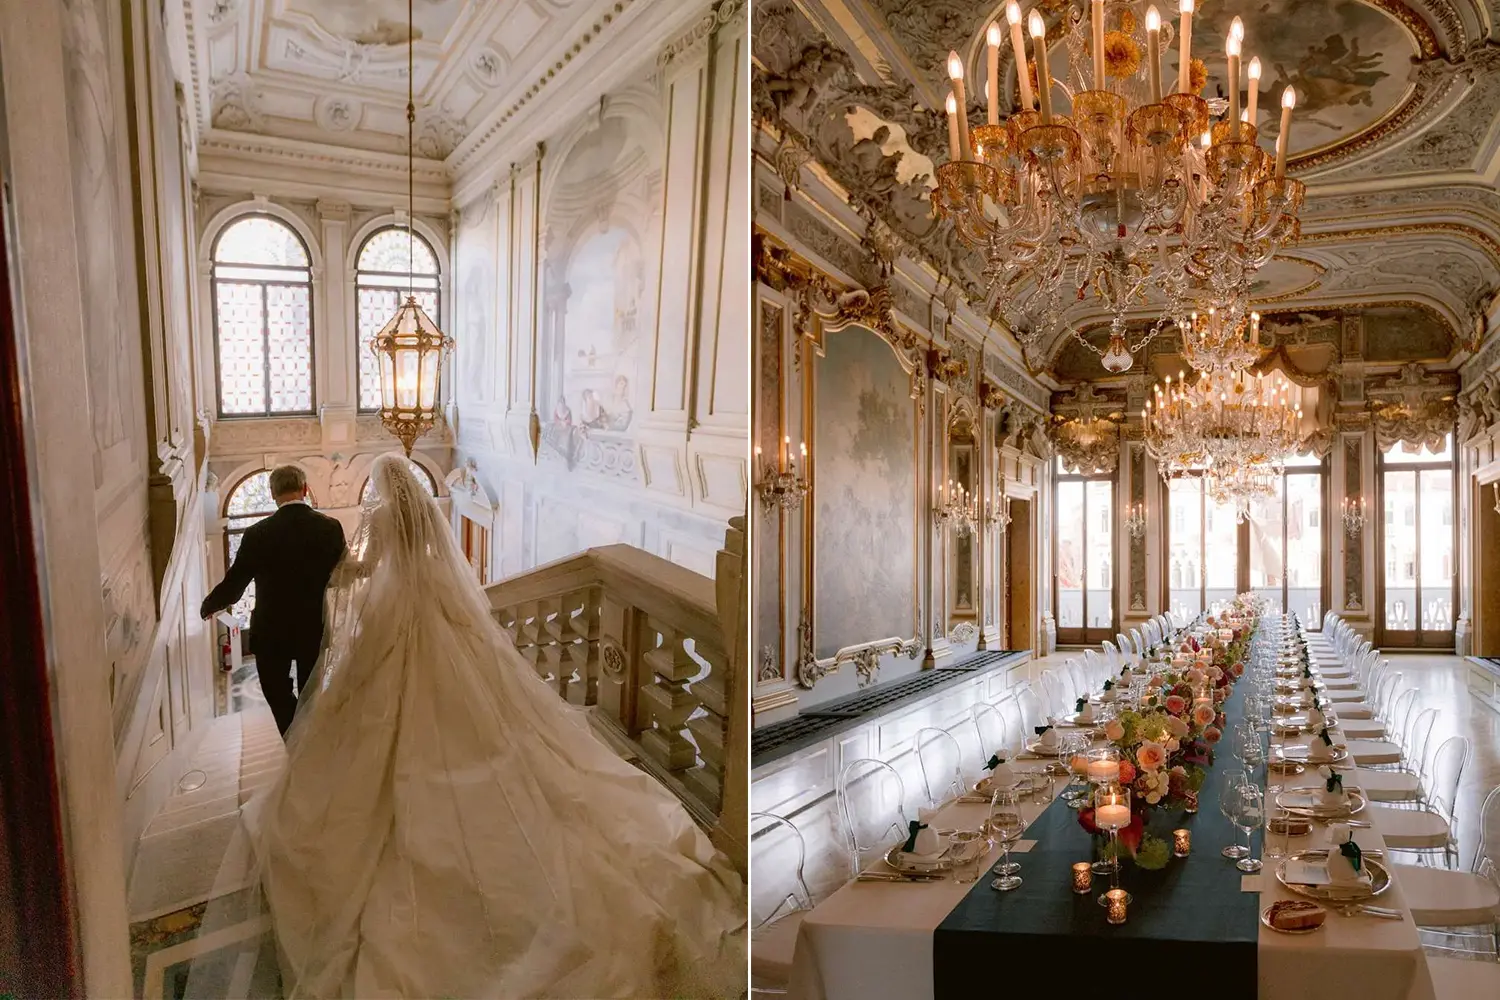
[1247,454,1323,622]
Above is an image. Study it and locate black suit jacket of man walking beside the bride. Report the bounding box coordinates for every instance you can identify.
[203,504,344,657]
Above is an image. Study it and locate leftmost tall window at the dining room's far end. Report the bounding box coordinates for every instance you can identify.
[1053,459,1115,643]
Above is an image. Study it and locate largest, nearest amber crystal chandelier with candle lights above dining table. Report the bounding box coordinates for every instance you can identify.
[933,0,1304,372]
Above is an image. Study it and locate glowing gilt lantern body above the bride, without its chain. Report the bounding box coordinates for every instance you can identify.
[371,295,452,456]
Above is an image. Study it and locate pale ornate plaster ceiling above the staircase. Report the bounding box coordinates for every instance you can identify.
[182,0,699,159]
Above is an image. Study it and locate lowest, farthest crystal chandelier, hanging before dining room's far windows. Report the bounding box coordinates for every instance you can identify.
[1142,361,1302,516]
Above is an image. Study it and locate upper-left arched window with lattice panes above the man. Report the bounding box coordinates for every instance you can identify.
[212,216,314,417]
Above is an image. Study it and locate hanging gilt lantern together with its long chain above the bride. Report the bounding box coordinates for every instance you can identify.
[371,0,453,457]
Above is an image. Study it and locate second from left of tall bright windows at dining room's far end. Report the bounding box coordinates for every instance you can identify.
[1167,477,1239,616]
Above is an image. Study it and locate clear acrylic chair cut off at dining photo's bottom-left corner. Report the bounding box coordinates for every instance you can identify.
[750,813,813,996]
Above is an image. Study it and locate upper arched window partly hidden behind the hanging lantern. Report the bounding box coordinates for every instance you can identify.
[354,226,440,412]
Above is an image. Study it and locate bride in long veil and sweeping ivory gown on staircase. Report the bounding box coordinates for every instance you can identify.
[246,456,746,1000]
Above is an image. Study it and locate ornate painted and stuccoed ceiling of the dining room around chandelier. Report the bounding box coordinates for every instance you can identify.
[755,0,1500,378]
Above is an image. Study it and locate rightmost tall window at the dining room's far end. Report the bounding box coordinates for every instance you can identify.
[1379,435,1454,648]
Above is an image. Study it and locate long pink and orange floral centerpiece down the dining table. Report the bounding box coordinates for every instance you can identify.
[1079,603,1260,868]
